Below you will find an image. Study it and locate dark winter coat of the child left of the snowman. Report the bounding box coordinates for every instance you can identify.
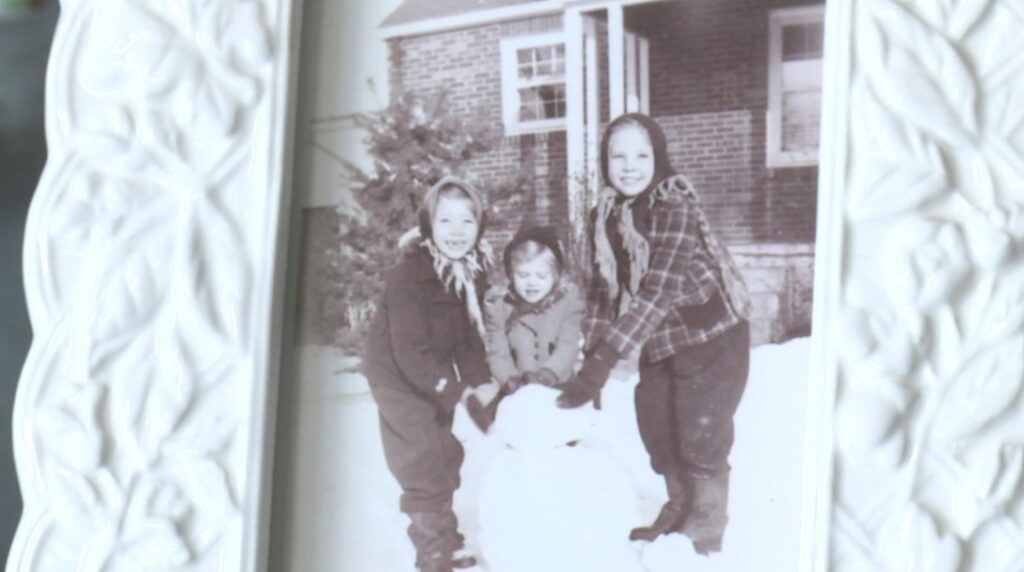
[364,247,490,413]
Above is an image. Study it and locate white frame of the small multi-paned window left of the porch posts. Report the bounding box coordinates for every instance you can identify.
[501,32,568,135]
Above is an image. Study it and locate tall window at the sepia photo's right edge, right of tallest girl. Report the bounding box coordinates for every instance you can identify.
[766,6,824,167]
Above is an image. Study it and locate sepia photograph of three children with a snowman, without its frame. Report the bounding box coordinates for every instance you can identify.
[269,0,828,572]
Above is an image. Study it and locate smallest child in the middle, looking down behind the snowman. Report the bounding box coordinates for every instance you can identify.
[466,226,584,431]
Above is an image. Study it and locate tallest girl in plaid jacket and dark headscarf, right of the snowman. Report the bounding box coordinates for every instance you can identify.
[558,114,750,555]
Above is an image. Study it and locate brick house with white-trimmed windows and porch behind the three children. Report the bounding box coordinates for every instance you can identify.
[381,0,824,343]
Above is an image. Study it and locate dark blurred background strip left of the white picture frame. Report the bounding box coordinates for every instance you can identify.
[0,0,59,562]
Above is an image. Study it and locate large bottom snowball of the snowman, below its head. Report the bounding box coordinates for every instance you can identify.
[479,445,644,572]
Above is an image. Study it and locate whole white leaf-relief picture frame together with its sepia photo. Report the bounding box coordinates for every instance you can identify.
[7,0,1024,572]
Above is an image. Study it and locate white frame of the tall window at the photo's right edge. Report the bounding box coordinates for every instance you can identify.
[765,4,825,168]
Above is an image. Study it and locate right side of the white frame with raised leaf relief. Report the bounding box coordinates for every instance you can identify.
[823,0,1024,572]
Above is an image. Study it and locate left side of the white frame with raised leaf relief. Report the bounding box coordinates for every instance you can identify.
[8,0,294,571]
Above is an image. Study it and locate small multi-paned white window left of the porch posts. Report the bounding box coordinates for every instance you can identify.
[502,34,565,134]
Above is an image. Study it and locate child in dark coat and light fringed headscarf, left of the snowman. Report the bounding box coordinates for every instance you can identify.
[365,177,490,572]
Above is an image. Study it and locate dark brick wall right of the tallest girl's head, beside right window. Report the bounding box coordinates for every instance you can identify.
[626,0,817,244]
